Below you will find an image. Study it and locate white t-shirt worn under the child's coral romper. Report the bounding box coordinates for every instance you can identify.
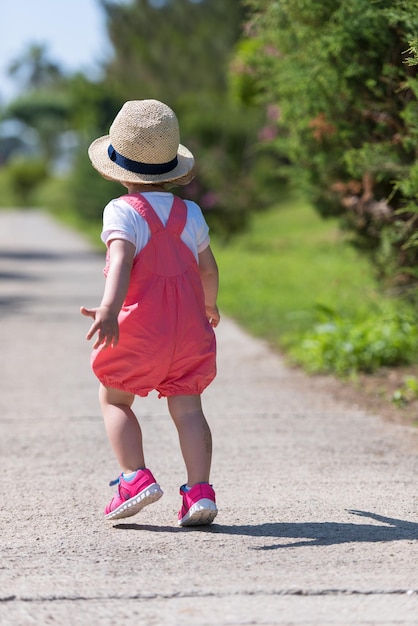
[101,191,210,261]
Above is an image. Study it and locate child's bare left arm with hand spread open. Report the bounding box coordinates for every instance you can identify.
[80,239,135,348]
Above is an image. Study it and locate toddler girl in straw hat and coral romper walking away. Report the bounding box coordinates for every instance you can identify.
[81,100,219,526]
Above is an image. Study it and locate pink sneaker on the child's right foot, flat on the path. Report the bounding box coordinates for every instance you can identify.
[178,483,218,526]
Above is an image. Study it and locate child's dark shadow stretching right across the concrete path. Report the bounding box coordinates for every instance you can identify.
[114,511,418,550]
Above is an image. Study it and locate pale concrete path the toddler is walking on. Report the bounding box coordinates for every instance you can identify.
[0,211,418,626]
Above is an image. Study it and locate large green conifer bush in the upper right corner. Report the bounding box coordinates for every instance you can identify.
[237,0,418,288]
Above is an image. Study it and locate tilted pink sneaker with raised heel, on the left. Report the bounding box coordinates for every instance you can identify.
[105,469,163,519]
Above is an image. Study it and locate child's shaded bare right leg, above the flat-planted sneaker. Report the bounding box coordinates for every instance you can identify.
[167,396,212,487]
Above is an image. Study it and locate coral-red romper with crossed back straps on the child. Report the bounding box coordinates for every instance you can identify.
[91,194,216,397]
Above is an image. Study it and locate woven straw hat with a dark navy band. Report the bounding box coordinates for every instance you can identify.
[89,100,194,184]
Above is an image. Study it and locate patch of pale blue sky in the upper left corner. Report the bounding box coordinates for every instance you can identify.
[0,0,109,103]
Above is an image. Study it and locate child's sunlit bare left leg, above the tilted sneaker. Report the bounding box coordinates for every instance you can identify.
[99,385,145,472]
